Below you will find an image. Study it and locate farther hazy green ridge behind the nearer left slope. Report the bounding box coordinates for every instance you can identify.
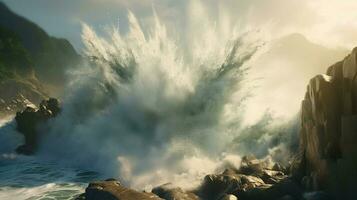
[0,2,81,86]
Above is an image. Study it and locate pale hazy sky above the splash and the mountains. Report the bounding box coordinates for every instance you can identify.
[2,0,357,48]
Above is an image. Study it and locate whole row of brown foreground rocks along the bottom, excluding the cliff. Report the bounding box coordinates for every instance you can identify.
[78,156,303,200]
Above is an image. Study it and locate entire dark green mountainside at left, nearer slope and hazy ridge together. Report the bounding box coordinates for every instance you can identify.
[0,2,81,116]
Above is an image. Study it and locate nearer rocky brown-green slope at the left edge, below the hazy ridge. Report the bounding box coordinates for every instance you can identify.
[0,23,46,117]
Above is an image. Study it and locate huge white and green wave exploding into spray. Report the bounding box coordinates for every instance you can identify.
[36,7,261,188]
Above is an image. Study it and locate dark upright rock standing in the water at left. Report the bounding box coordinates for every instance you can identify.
[15,98,60,155]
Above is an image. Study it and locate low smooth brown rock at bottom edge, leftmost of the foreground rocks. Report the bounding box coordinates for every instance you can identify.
[76,180,161,200]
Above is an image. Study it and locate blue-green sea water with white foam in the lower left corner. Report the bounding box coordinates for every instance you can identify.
[0,119,103,200]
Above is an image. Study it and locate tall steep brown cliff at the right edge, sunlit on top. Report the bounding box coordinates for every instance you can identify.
[299,48,357,199]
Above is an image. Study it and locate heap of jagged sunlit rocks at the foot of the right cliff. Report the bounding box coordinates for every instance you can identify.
[198,156,303,200]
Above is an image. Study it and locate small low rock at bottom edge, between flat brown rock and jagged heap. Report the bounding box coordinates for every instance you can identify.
[152,183,199,200]
